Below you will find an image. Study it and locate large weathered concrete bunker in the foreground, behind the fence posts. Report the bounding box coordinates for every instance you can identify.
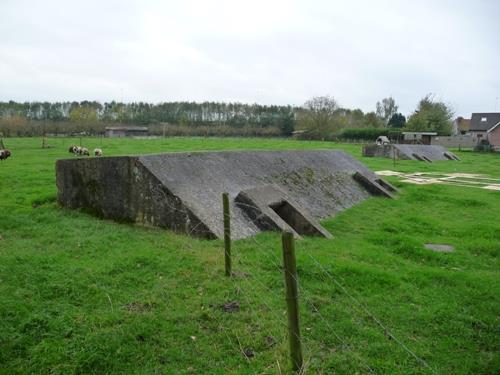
[56,150,395,239]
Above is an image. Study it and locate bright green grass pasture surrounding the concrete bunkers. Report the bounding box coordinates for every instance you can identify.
[0,138,500,374]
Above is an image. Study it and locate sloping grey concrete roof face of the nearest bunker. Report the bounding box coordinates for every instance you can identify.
[138,150,379,238]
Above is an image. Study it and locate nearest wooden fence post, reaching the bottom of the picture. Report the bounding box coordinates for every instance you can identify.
[282,231,302,371]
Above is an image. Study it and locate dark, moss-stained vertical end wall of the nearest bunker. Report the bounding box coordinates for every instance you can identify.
[56,157,215,238]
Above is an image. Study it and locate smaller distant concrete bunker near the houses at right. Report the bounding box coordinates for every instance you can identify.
[363,144,460,163]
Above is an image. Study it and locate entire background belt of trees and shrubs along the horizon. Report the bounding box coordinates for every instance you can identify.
[0,95,453,139]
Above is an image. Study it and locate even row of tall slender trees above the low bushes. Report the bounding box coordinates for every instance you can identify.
[0,101,293,128]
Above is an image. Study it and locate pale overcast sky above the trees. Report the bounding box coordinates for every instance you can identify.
[0,0,500,116]
